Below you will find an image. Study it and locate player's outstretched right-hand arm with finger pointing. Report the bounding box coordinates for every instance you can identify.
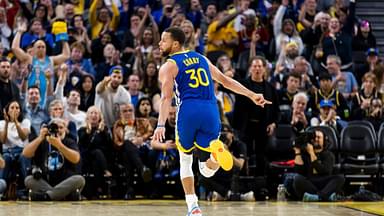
[208,61,272,107]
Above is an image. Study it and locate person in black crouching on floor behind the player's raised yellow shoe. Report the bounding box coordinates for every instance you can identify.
[200,124,255,201]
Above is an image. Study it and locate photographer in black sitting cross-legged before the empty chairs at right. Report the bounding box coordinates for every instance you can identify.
[293,130,345,202]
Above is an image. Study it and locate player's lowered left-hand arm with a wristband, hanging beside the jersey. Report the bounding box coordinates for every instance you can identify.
[153,62,177,142]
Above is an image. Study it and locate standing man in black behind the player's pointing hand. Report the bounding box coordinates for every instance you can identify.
[233,56,279,176]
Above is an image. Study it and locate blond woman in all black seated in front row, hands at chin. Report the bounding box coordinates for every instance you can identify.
[78,106,113,198]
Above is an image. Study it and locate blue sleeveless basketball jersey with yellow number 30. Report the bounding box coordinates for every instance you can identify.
[168,51,216,103]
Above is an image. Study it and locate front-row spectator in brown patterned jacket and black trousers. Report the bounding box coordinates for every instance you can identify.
[113,104,153,199]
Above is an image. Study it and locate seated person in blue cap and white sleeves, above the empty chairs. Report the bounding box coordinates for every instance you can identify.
[311,100,347,134]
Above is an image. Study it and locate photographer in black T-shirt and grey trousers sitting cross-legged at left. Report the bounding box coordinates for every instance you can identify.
[22,118,85,201]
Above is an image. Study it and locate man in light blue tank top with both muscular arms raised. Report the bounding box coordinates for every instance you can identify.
[12,20,70,106]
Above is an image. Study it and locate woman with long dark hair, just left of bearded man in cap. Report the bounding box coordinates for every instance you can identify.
[79,74,96,112]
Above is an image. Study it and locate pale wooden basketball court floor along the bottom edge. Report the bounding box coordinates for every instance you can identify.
[0,200,384,216]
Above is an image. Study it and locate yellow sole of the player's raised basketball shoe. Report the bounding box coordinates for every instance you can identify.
[209,139,233,171]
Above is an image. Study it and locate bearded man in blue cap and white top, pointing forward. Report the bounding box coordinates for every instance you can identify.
[95,66,131,128]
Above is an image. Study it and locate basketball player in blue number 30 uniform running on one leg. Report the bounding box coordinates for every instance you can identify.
[153,27,271,216]
